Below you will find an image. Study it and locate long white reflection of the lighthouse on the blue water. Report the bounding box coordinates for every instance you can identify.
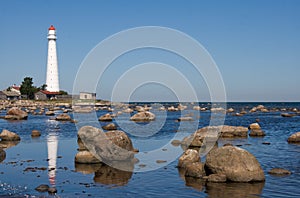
[47,133,58,187]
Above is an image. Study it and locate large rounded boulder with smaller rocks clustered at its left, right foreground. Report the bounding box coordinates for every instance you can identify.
[178,146,265,183]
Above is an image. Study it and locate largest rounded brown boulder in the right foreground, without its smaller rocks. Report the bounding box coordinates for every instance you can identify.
[205,146,265,182]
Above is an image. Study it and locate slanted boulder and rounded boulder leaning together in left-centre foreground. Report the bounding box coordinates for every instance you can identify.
[78,126,134,163]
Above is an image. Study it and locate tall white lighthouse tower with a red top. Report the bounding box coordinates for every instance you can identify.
[46,25,59,92]
